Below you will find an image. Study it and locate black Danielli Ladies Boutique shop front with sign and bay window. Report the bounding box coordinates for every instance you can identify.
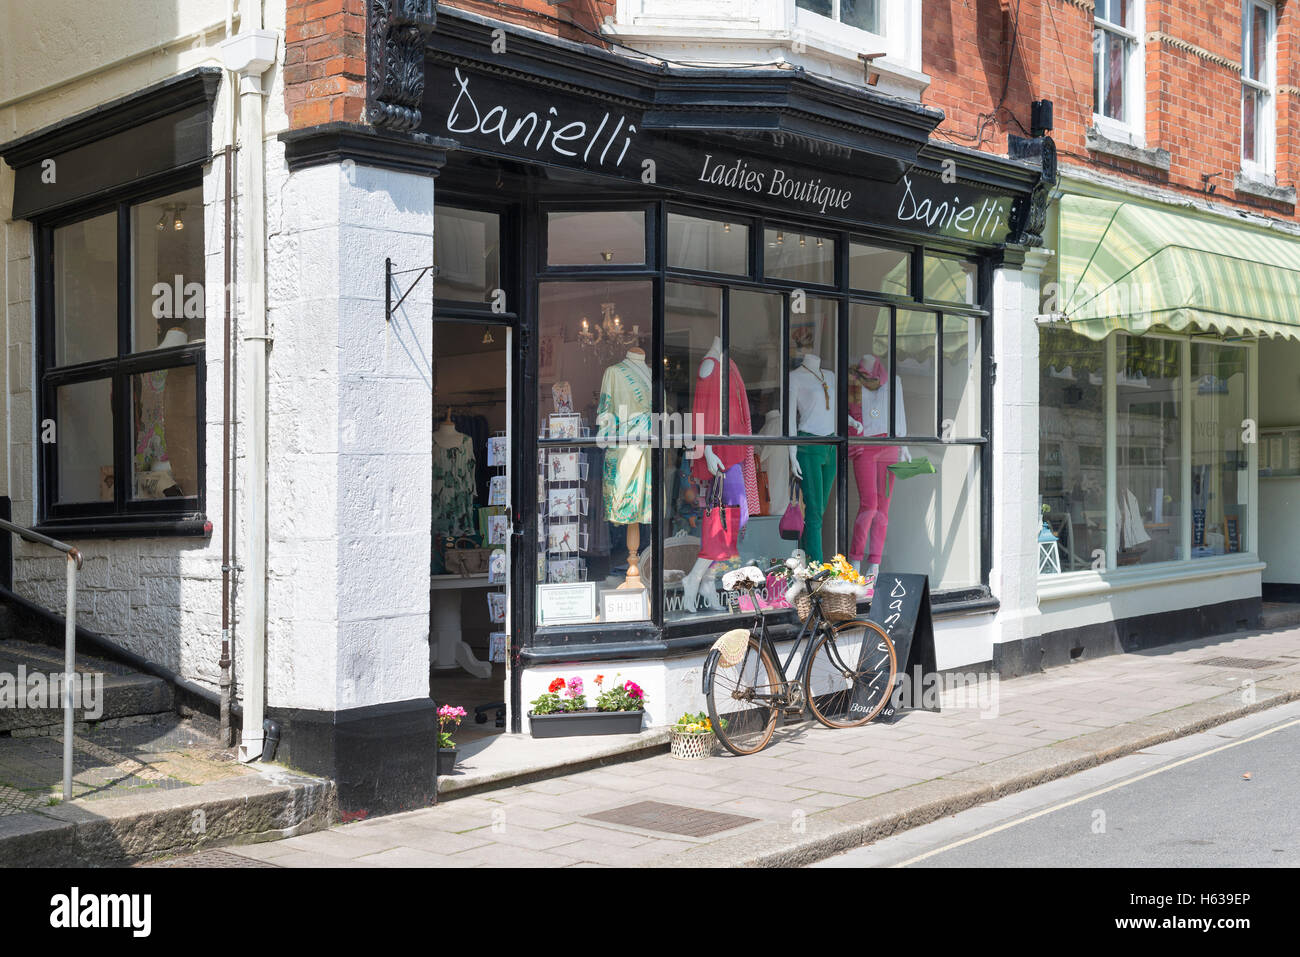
[364,10,1040,732]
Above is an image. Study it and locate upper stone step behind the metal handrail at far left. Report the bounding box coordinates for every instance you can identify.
[0,638,176,735]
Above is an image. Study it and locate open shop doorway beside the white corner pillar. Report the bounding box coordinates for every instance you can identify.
[429,319,514,761]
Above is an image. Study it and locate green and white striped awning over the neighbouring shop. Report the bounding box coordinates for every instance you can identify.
[1045,194,1300,339]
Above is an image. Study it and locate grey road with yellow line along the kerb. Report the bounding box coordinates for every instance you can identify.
[813,702,1300,869]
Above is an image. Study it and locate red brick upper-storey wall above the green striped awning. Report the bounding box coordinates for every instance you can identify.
[922,0,1300,218]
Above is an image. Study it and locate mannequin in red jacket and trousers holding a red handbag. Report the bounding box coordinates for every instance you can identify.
[681,335,758,614]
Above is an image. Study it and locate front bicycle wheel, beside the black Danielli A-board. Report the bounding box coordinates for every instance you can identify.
[807,619,898,728]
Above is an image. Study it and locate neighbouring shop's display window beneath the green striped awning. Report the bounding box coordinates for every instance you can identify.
[1039,328,1251,573]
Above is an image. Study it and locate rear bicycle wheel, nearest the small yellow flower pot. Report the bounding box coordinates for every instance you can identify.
[705,637,781,754]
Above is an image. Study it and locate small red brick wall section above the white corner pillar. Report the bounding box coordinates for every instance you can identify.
[285,0,365,129]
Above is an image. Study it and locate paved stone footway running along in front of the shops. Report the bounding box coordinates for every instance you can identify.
[174,628,1300,867]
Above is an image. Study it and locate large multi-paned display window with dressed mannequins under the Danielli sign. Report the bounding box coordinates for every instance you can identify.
[537,208,987,627]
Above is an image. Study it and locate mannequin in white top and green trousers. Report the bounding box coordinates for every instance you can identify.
[789,352,855,562]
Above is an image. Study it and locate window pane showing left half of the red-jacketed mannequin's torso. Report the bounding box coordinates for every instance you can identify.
[663,282,722,421]
